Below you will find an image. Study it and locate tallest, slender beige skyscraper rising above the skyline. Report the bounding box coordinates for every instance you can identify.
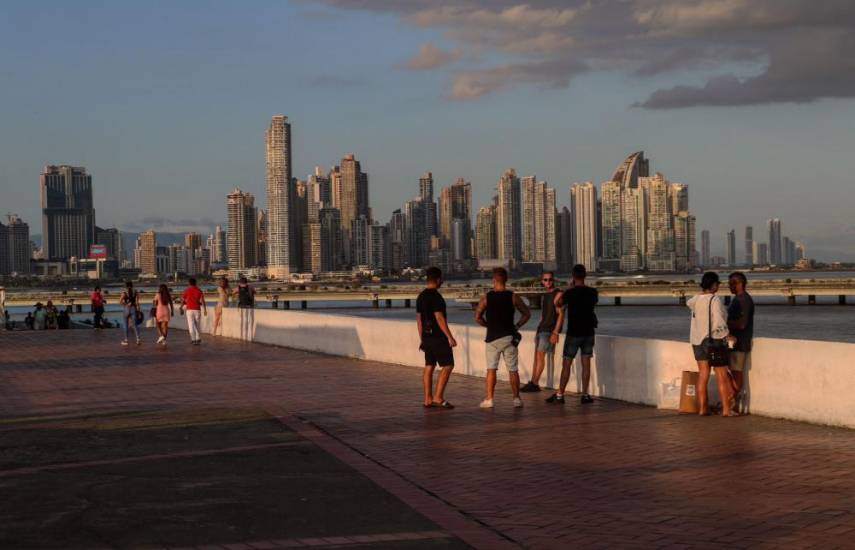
[266,115,294,279]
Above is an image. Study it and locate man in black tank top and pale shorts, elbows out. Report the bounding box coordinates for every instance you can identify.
[475,267,531,409]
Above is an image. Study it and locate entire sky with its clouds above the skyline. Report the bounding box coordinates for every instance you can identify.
[0,0,855,261]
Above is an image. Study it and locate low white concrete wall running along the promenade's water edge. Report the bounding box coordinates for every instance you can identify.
[173,308,855,428]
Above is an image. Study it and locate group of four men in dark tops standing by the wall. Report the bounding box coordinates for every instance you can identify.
[416,265,598,409]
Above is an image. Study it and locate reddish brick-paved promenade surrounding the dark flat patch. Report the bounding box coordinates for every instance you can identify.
[0,330,855,548]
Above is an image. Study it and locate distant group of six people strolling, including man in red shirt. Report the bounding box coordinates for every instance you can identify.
[104,277,255,346]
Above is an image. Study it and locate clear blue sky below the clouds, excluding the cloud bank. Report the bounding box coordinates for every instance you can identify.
[0,0,855,259]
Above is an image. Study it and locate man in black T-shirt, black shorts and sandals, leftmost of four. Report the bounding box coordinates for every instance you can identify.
[416,267,457,409]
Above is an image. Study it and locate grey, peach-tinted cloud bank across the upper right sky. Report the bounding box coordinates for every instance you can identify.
[304,0,855,109]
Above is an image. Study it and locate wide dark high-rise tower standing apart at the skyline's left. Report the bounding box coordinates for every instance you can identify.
[40,165,95,260]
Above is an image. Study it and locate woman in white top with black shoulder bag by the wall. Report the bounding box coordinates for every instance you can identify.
[686,271,739,416]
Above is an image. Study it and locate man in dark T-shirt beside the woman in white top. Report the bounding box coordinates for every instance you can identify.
[727,271,754,409]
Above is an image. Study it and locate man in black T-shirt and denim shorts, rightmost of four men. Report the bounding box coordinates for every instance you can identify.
[546,264,599,405]
